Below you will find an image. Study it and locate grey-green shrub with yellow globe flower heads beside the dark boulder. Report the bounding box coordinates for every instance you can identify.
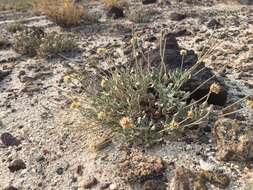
[67,35,220,146]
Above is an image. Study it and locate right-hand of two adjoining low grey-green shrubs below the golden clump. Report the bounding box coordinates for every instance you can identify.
[38,32,78,56]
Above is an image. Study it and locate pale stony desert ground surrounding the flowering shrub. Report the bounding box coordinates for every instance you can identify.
[0,1,253,190]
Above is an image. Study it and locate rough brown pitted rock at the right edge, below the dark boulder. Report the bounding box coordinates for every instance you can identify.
[213,118,253,161]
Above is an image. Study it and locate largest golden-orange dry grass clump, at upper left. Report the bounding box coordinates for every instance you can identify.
[34,0,87,27]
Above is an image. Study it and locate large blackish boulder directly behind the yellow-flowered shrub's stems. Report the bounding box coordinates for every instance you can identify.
[146,33,227,106]
